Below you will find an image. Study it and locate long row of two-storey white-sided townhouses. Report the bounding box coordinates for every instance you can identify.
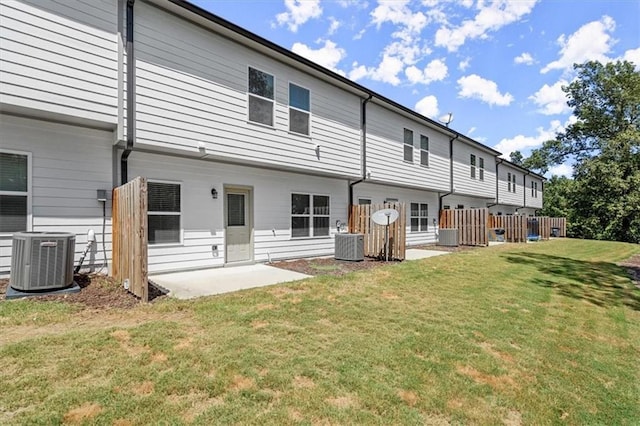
[0,0,543,274]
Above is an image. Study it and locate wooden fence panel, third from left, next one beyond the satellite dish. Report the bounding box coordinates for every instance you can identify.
[439,209,489,246]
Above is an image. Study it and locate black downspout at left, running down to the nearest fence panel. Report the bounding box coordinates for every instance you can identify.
[120,0,136,185]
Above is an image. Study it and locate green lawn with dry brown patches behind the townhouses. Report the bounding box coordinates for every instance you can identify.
[0,240,640,425]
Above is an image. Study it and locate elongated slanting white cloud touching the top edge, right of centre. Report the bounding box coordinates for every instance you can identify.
[435,0,537,52]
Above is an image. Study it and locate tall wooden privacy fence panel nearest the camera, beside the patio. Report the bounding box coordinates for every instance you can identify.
[112,177,149,302]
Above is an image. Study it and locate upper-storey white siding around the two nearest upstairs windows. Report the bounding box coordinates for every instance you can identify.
[135,2,362,176]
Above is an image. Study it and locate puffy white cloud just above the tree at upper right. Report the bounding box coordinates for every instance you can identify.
[540,15,616,74]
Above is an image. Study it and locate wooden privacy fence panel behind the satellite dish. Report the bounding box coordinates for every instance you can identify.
[349,203,407,260]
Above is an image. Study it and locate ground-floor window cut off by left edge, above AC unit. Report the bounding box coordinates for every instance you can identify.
[0,151,31,233]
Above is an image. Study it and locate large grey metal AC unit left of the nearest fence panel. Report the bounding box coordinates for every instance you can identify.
[9,232,76,291]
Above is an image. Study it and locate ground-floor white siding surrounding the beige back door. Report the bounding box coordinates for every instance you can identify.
[129,152,348,273]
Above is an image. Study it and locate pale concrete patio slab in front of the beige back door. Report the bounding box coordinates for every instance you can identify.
[149,264,311,299]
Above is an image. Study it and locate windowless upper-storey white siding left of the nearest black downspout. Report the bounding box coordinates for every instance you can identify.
[0,0,118,125]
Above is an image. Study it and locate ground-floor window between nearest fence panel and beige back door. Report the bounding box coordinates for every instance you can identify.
[147,181,182,244]
